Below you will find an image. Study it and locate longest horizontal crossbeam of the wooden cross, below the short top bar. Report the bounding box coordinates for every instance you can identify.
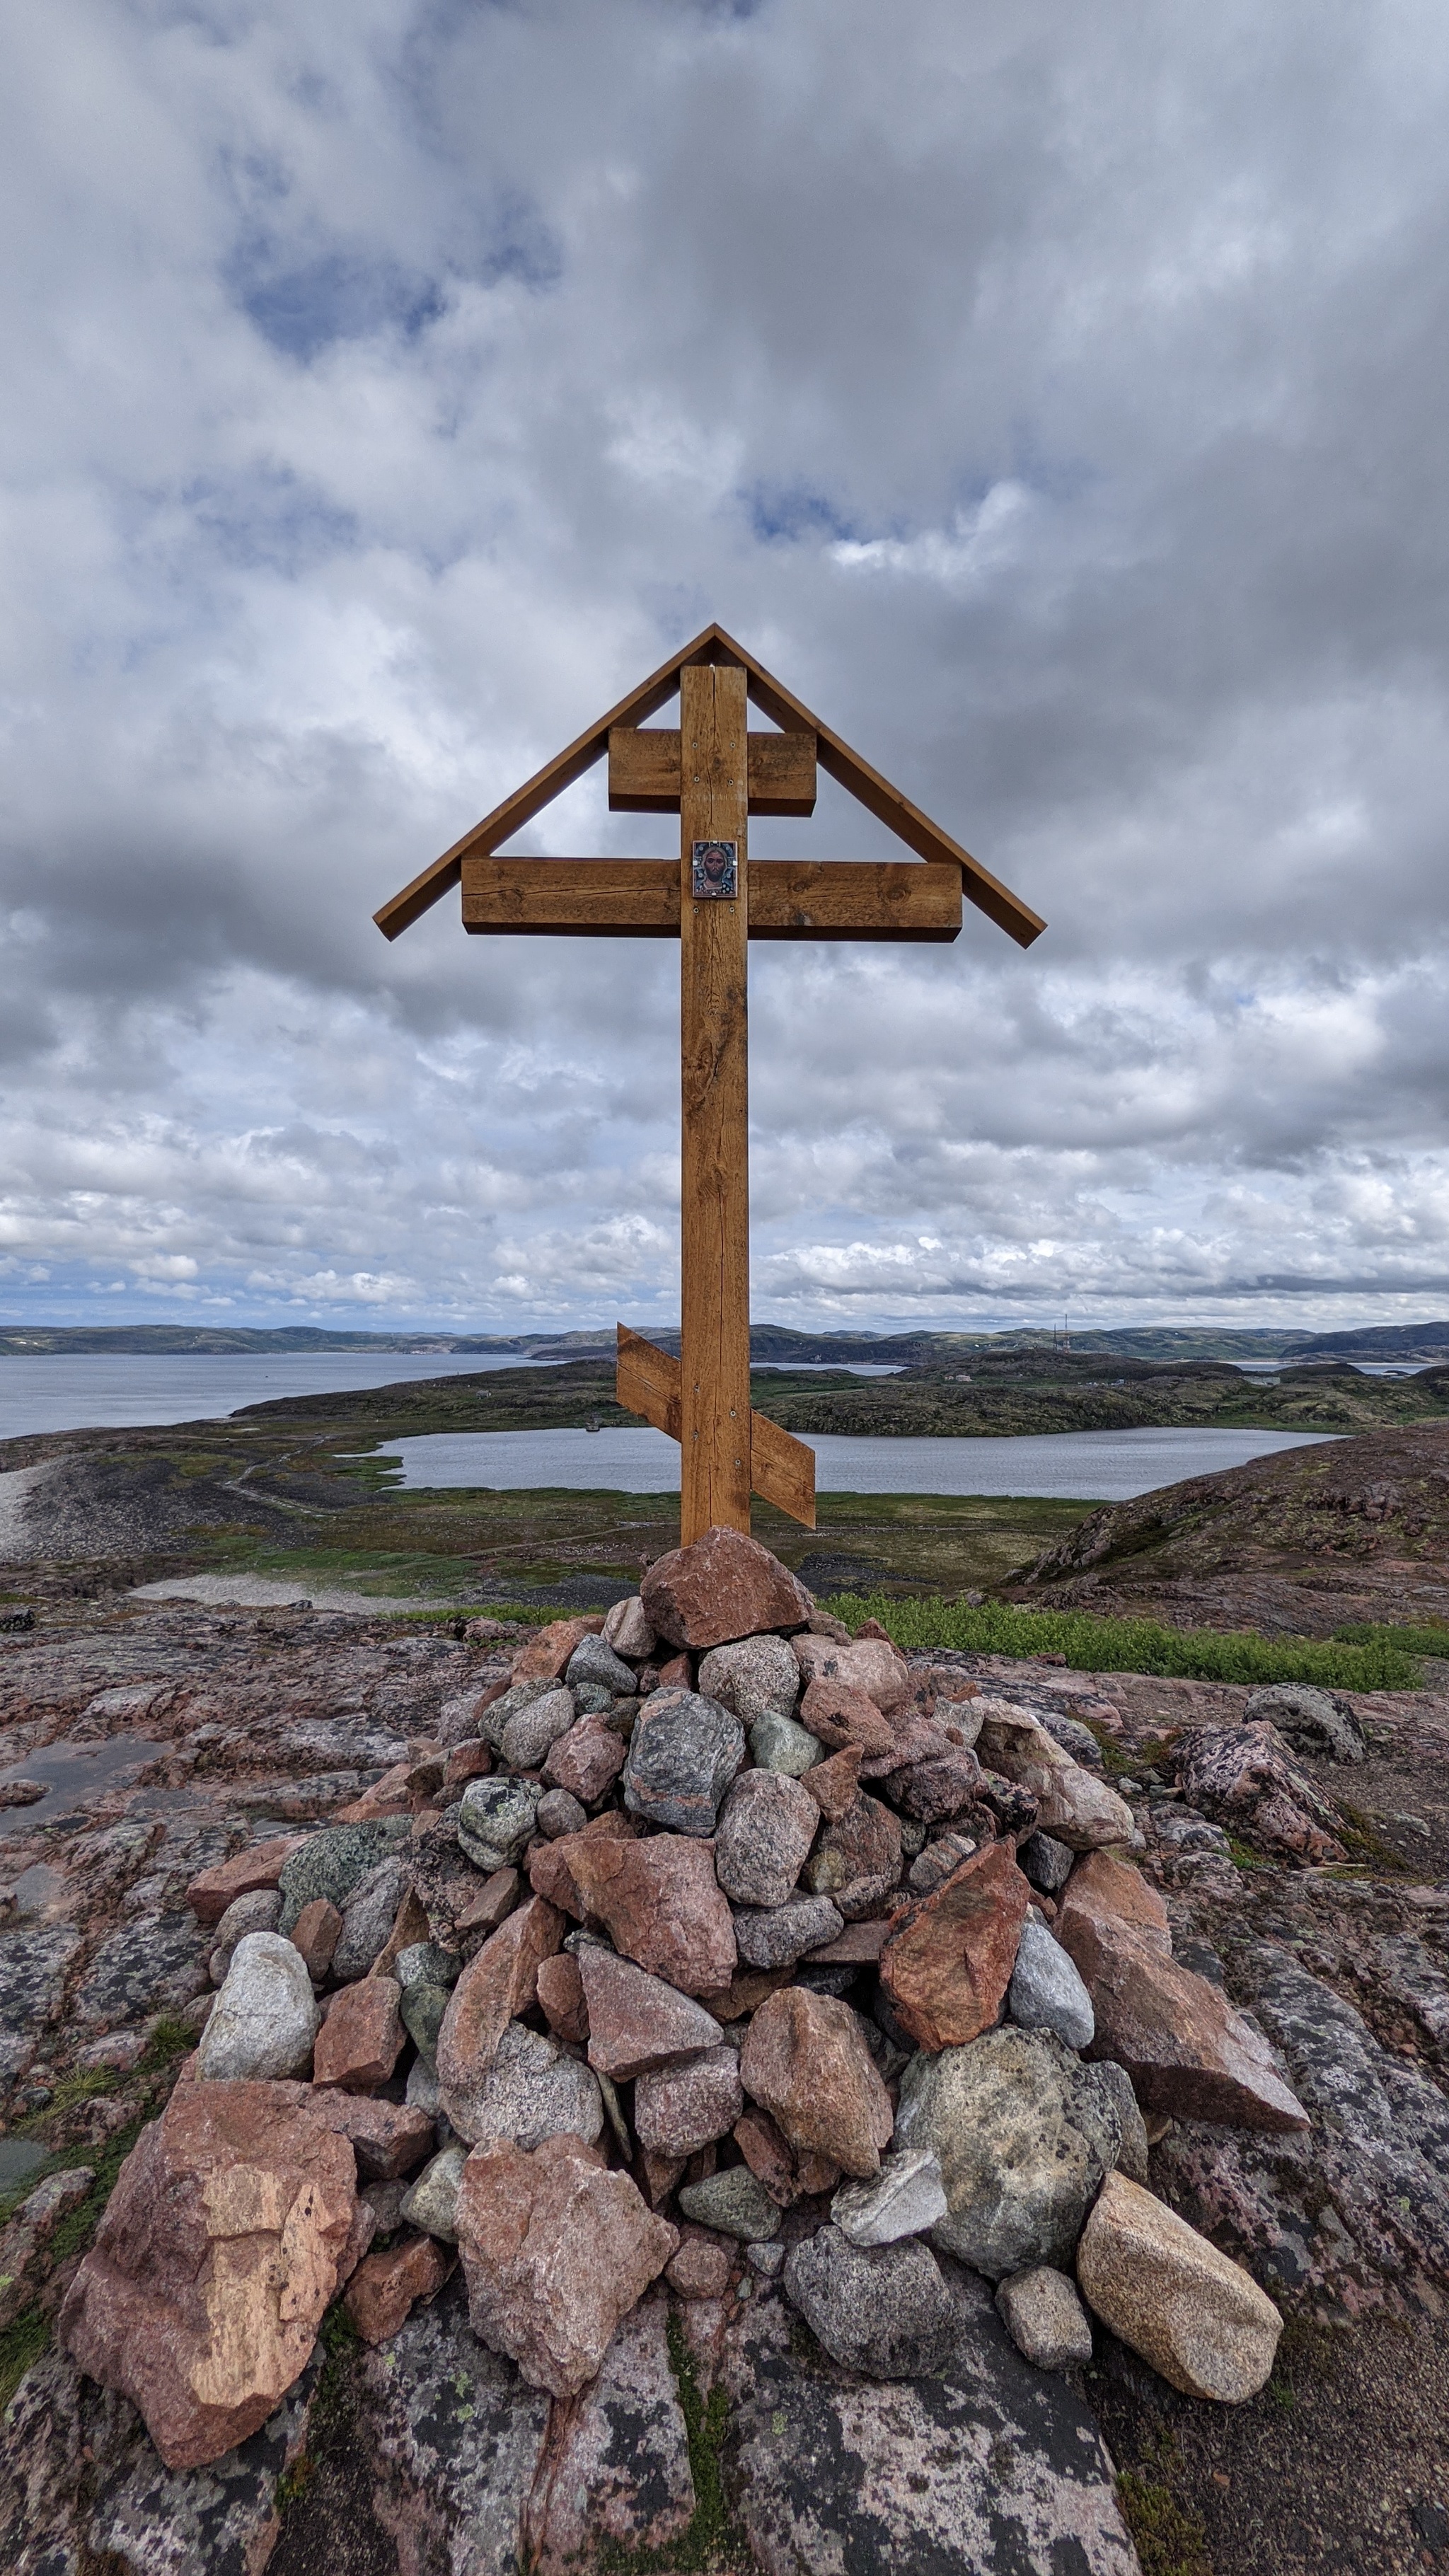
[461,857,962,943]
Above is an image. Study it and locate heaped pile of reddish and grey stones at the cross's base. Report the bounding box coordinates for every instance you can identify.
[59,1530,1307,2468]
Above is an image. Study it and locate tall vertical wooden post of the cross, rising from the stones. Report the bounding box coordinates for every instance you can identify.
[681,662,750,1548]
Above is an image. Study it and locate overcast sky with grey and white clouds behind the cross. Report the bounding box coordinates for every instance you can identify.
[0,0,1449,1329]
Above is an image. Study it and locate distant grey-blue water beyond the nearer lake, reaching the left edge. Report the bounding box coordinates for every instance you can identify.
[0,1350,897,1440]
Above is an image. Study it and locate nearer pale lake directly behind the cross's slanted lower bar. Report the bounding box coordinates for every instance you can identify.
[369,1430,1333,1502]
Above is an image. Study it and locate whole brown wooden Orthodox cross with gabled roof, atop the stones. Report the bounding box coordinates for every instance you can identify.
[376,626,1047,1546]
